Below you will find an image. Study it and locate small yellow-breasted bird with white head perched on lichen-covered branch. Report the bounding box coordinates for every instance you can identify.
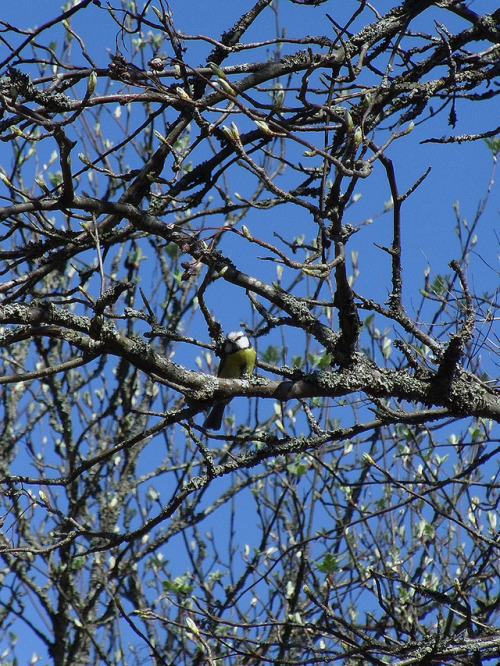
[203,331,257,430]
